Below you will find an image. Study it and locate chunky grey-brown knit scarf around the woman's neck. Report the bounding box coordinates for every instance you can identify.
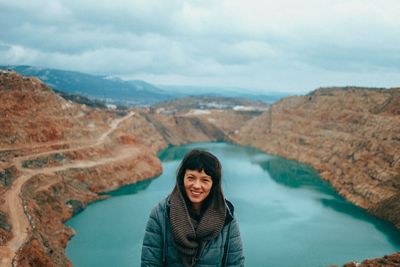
[170,185,226,267]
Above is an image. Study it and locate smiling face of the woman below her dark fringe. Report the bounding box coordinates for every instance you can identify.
[183,170,212,209]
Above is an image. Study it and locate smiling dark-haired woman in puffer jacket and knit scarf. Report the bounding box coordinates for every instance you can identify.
[141,150,244,267]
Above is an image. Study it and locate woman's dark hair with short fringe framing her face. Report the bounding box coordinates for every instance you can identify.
[176,149,222,213]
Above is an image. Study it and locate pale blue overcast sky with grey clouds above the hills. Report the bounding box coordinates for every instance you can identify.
[0,0,400,93]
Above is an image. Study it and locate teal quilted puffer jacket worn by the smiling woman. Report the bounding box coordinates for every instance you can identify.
[141,198,244,267]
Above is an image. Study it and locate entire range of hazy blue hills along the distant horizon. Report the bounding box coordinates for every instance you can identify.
[0,65,290,107]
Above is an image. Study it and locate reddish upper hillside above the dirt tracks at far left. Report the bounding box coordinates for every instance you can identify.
[0,73,113,148]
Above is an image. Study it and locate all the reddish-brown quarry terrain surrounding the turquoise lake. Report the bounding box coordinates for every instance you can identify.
[0,72,400,266]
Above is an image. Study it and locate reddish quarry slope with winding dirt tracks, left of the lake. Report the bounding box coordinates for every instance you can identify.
[0,72,164,266]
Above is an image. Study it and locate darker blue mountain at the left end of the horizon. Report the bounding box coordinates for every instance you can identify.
[0,66,173,106]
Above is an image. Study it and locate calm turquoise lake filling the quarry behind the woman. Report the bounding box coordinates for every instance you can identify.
[66,143,400,267]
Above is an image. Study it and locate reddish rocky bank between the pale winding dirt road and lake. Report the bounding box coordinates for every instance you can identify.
[16,149,161,266]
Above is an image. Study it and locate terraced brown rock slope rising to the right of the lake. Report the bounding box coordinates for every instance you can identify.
[234,88,400,229]
